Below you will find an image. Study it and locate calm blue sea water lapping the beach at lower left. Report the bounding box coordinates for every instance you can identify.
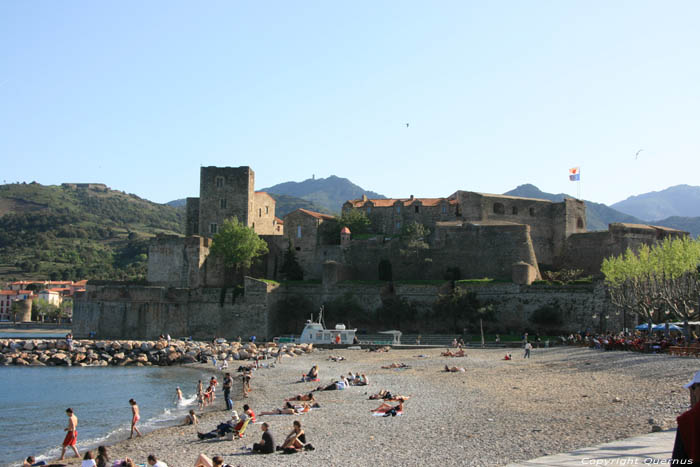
[0,366,215,466]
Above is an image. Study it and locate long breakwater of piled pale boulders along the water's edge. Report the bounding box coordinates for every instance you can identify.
[0,339,313,366]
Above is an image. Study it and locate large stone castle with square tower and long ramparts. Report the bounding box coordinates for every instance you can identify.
[74,167,685,338]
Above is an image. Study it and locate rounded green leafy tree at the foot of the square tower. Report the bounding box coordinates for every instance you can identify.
[211,217,268,270]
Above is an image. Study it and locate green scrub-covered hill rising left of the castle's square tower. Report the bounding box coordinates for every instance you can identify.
[0,183,184,281]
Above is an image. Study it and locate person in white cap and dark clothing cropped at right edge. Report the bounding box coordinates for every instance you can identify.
[671,371,700,465]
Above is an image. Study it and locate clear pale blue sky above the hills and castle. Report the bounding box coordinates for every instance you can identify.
[0,0,700,204]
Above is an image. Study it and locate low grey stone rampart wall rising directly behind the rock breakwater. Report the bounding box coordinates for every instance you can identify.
[73,277,275,339]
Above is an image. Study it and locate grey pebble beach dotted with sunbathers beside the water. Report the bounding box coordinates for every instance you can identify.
[46,347,700,467]
